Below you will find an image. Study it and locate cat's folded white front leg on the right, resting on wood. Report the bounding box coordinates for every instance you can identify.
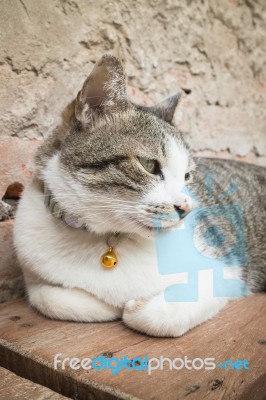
[123,293,228,337]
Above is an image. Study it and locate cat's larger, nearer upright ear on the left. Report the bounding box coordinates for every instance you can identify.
[75,54,129,123]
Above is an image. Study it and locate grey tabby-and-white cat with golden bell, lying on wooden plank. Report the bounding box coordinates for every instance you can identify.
[14,54,266,337]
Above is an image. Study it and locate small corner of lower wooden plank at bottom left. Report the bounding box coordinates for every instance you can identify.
[0,367,70,400]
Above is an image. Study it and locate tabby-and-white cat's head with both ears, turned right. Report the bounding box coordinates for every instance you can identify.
[42,55,193,237]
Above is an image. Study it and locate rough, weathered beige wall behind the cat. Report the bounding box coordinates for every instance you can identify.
[0,0,266,300]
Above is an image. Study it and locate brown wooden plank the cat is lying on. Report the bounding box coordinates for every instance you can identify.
[0,294,266,400]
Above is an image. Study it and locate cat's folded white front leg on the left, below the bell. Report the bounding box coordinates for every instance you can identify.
[27,284,122,322]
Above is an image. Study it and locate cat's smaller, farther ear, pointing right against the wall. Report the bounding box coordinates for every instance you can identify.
[140,92,182,123]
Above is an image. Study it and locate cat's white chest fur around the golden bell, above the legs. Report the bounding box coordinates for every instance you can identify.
[15,180,181,306]
